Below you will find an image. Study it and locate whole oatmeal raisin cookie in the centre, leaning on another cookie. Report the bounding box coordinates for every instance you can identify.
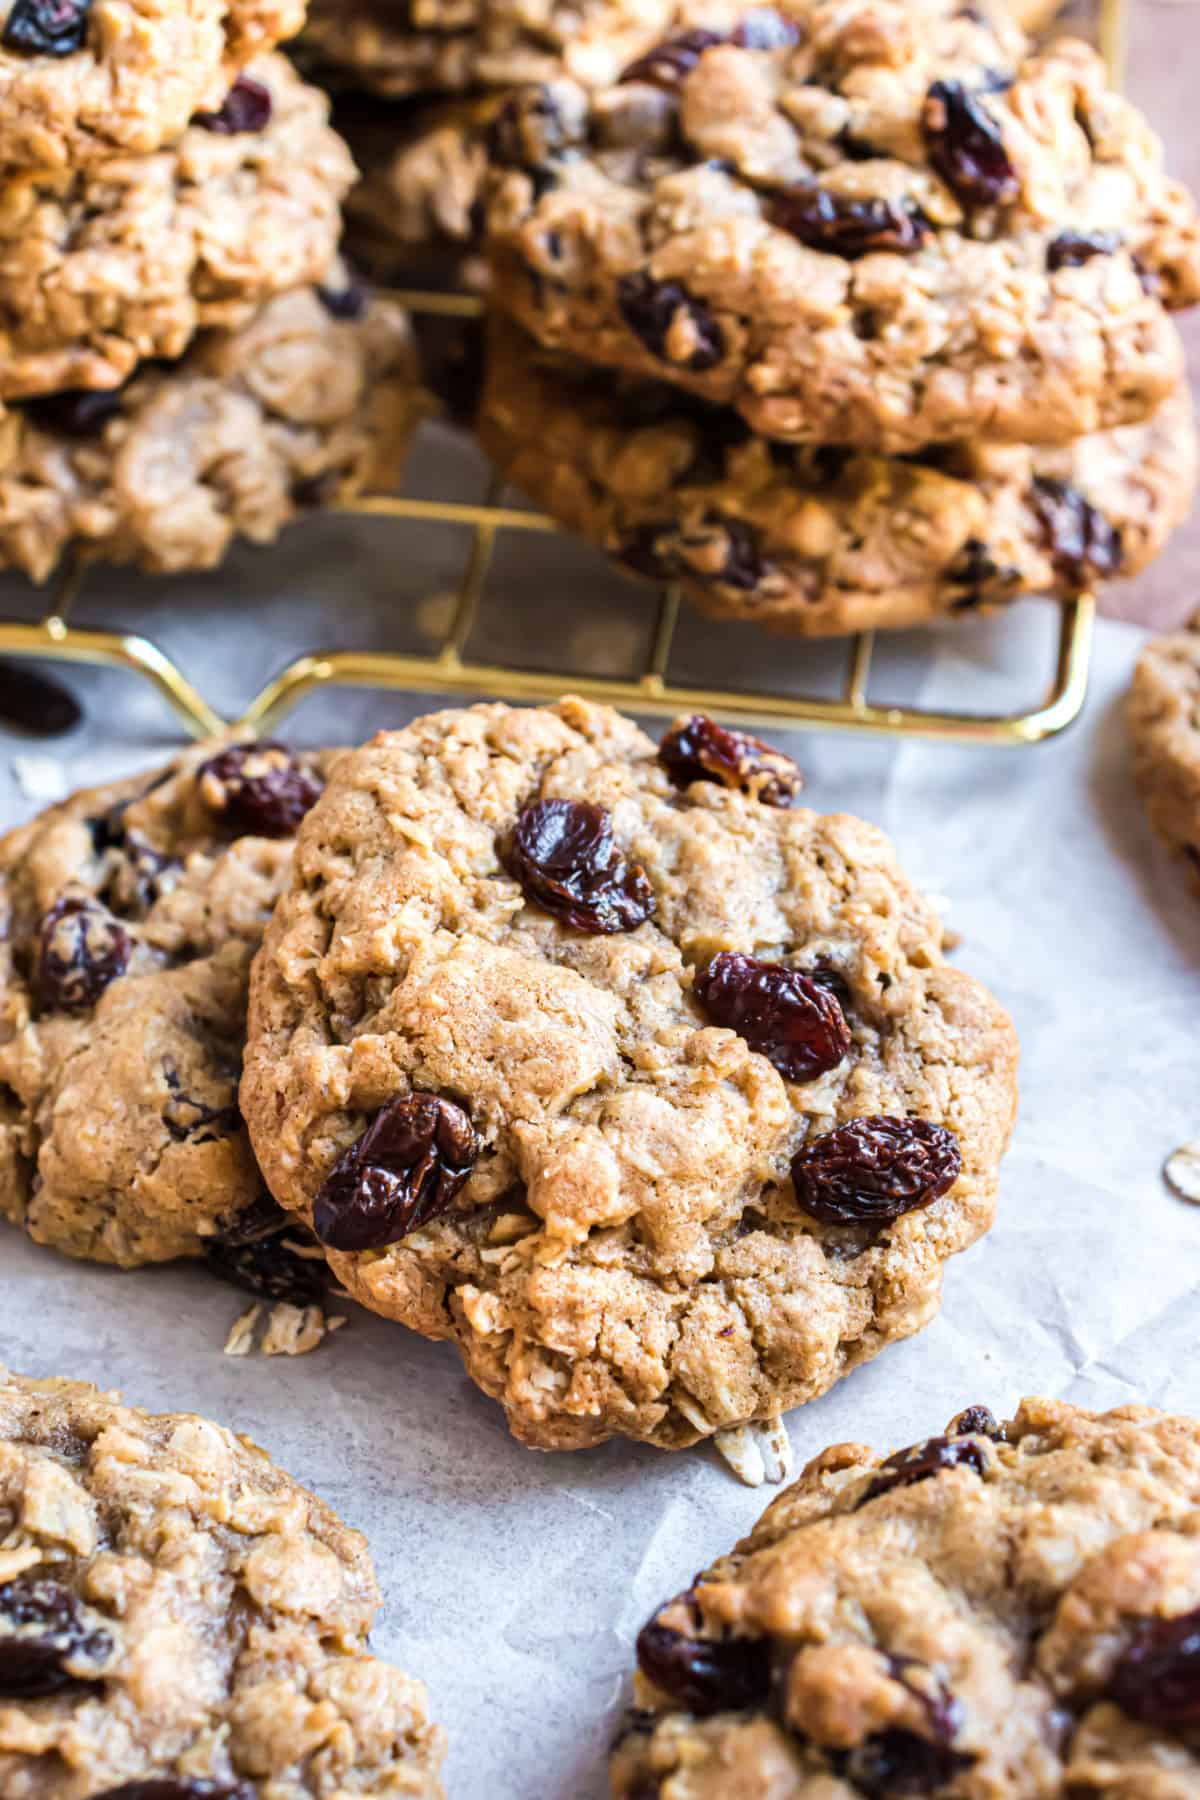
[241,700,1016,1449]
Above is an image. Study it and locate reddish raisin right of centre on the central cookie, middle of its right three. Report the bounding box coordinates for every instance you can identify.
[696,950,851,1082]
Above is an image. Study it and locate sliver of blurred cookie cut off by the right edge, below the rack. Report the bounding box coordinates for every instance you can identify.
[1128,619,1200,889]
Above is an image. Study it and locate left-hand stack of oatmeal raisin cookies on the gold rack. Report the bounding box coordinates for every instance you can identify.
[0,0,426,580]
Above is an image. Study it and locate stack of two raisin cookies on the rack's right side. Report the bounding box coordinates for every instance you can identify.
[467,0,1200,634]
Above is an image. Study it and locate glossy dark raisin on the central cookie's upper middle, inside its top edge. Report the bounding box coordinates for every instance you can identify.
[507,799,655,936]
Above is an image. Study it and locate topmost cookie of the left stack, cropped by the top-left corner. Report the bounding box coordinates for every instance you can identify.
[0,0,304,180]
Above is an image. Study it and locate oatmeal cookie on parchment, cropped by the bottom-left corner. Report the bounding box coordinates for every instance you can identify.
[0,1372,444,1800]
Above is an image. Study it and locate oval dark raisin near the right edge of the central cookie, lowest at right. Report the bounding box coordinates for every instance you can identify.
[792,1114,963,1226]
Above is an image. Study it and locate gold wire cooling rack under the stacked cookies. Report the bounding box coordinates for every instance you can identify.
[0,0,1128,745]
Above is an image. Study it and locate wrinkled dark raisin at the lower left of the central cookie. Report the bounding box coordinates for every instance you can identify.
[313,1093,479,1249]
